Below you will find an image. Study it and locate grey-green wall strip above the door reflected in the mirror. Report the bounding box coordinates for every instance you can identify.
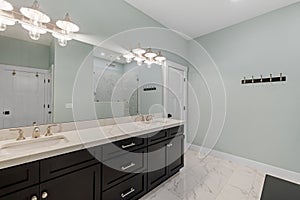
[0,36,50,69]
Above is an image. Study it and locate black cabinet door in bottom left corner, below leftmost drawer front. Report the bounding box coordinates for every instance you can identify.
[0,186,39,200]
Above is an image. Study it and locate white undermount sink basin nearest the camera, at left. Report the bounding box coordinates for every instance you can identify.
[0,135,69,153]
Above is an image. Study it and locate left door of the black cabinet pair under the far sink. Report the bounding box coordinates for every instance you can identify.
[148,142,168,190]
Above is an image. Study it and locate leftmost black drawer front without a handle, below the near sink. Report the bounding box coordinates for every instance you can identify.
[0,162,39,196]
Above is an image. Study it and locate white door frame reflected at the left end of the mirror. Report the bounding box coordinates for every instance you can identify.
[0,64,53,129]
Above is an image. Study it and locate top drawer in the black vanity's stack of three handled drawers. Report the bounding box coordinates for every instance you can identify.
[102,136,147,160]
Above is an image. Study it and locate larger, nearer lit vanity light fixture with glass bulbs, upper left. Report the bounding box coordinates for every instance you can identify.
[0,0,79,46]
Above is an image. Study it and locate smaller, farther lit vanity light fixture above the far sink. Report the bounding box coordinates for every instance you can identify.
[123,47,167,66]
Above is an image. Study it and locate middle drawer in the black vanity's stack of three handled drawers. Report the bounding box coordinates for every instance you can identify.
[102,149,147,190]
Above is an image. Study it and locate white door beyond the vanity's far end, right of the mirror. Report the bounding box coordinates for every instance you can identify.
[165,64,186,120]
